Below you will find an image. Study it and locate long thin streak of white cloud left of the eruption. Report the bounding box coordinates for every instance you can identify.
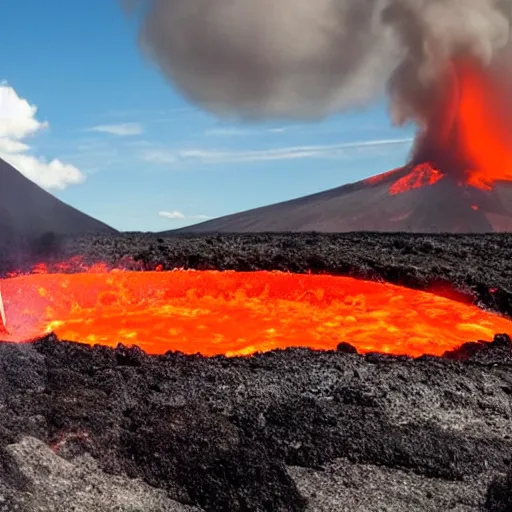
[140,138,413,164]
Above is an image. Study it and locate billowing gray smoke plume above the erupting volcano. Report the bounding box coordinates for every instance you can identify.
[130,0,512,123]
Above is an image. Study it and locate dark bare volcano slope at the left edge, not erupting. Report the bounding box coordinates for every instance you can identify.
[0,159,116,246]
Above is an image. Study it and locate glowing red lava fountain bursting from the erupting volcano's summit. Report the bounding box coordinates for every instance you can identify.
[389,61,512,195]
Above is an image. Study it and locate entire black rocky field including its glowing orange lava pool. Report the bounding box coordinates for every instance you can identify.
[0,234,512,512]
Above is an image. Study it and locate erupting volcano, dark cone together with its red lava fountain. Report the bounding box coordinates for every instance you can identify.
[171,62,512,233]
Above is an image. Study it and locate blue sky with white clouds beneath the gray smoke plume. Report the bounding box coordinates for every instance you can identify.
[0,0,412,231]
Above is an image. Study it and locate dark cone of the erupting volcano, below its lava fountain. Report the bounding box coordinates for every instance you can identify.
[165,165,512,234]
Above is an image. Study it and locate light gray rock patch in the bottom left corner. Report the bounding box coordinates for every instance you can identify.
[0,437,200,512]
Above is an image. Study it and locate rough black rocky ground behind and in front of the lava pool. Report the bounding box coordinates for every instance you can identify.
[0,234,512,512]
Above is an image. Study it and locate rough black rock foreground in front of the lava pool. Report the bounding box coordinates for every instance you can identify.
[0,336,512,512]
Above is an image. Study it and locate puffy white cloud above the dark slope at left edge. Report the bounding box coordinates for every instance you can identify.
[0,82,85,189]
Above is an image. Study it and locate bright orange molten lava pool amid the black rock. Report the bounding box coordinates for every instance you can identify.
[0,270,512,356]
